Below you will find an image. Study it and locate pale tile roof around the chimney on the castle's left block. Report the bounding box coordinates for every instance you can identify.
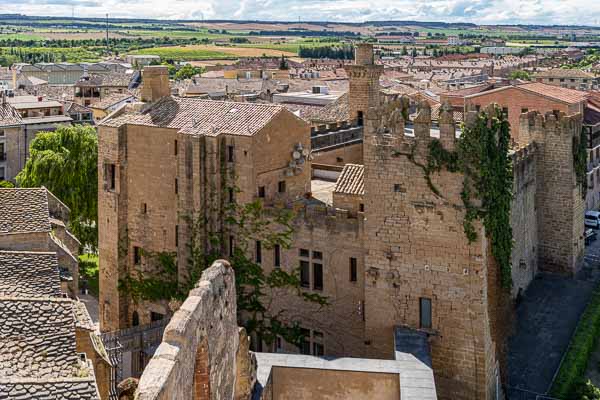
[102,97,288,136]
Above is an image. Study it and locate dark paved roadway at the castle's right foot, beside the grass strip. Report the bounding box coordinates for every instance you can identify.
[508,239,600,400]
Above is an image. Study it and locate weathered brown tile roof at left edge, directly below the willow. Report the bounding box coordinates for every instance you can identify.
[0,188,51,235]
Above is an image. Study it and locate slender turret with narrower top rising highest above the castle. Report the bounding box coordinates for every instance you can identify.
[344,43,383,125]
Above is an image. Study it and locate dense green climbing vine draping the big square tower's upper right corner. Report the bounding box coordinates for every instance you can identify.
[396,109,513,289]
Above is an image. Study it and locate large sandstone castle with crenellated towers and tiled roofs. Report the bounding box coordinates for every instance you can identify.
[98,45,584,399]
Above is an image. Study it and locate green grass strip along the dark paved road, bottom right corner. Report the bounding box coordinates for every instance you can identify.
[550,286,600,399]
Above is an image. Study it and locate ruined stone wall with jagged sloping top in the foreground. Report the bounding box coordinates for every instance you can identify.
[136,261,254,400]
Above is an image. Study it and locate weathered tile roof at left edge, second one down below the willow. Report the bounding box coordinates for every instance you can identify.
[0,251,61,298]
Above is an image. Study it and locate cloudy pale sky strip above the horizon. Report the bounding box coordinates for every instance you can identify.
[0,0,600,25]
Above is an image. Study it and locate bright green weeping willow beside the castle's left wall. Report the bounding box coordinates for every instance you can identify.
[17,125,98,248]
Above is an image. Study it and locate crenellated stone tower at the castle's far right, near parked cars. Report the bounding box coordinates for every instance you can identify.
[520,111,587,275]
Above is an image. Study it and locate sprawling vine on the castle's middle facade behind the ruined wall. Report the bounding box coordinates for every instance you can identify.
[119,197,328,346]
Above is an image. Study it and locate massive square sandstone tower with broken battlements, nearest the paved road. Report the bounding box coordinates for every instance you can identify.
[364,99,503,400]
